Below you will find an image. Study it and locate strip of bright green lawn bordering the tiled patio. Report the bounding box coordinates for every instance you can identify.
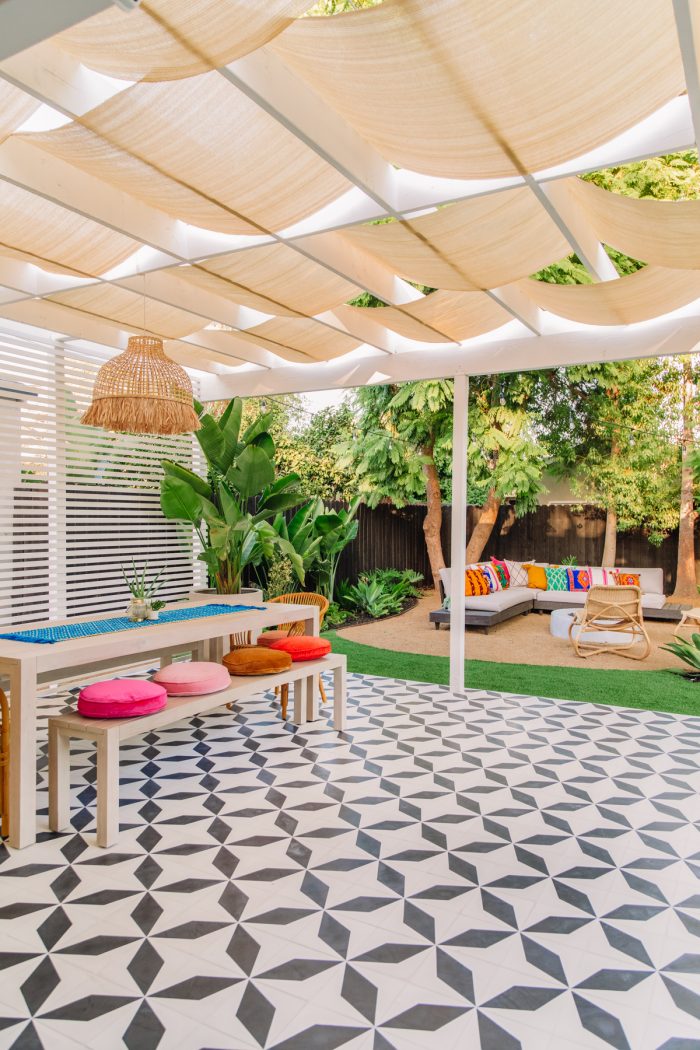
[324,631,700,715]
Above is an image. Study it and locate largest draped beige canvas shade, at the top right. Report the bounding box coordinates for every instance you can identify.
[270,0,685,179]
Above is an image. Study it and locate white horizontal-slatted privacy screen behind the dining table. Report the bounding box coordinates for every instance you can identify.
[0,332,205,625]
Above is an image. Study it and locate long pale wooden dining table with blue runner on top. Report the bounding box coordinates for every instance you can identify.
[0,594,319,849]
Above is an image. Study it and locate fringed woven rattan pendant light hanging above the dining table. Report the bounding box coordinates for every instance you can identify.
[81,335,200,434]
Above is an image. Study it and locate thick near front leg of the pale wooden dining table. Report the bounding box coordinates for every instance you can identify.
[8,658,37,849]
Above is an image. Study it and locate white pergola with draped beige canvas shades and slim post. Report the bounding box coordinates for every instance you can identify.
[0,0,700,689]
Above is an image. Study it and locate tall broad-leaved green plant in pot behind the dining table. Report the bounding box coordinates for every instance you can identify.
[161,398,304,594]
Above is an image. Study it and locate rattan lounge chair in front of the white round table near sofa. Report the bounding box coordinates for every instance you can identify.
[569,586,652,659]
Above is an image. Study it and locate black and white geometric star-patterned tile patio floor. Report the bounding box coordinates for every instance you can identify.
[0,675,700,1050]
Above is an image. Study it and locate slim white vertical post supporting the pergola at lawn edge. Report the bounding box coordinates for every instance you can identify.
[449,375,469,692]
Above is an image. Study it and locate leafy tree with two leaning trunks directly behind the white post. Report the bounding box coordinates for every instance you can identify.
[338,375,546,587]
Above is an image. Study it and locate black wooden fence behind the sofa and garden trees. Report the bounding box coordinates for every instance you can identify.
[338,504,678,593]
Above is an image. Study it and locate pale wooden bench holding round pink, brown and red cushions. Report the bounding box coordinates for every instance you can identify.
[48,653,347,846]
